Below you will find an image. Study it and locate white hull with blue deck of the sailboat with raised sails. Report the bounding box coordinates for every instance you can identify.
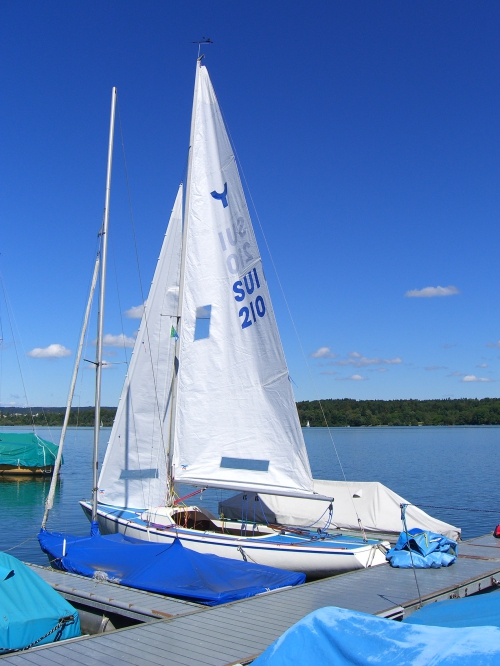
[81,502,389,579]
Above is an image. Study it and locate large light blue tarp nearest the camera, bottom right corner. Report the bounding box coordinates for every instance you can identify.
[252,607,500,666]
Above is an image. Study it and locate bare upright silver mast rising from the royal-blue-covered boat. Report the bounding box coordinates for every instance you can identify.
[91,88,117,534]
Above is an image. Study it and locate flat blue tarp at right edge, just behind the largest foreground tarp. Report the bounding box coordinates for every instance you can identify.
[404,590,500,627]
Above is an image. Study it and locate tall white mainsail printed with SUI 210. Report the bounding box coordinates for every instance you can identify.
[173,65,313,495]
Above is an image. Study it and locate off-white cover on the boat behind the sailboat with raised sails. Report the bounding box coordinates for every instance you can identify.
[219,479,460,541]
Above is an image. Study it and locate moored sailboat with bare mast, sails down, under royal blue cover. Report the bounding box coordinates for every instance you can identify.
[38,88,305,605]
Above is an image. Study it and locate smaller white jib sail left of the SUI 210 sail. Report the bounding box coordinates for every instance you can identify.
[99,185,182,509]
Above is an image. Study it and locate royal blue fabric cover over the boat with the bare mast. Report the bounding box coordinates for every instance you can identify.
[38,530,305,606]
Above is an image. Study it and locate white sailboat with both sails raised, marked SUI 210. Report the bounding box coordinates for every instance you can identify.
[81,56,389,578]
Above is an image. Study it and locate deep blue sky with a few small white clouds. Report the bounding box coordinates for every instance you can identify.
[0,0,500,406]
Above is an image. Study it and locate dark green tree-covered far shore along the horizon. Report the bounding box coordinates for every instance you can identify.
[0,398,500,428]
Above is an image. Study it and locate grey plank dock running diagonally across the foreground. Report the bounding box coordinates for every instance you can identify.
[3,535,500,666]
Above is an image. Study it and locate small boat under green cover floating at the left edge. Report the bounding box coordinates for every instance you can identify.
[0,432,57,475]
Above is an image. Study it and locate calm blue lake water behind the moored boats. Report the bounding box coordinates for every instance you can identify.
[0,426,500,564]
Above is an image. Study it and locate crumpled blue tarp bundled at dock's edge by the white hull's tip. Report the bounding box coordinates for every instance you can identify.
[386,527,458,569]
